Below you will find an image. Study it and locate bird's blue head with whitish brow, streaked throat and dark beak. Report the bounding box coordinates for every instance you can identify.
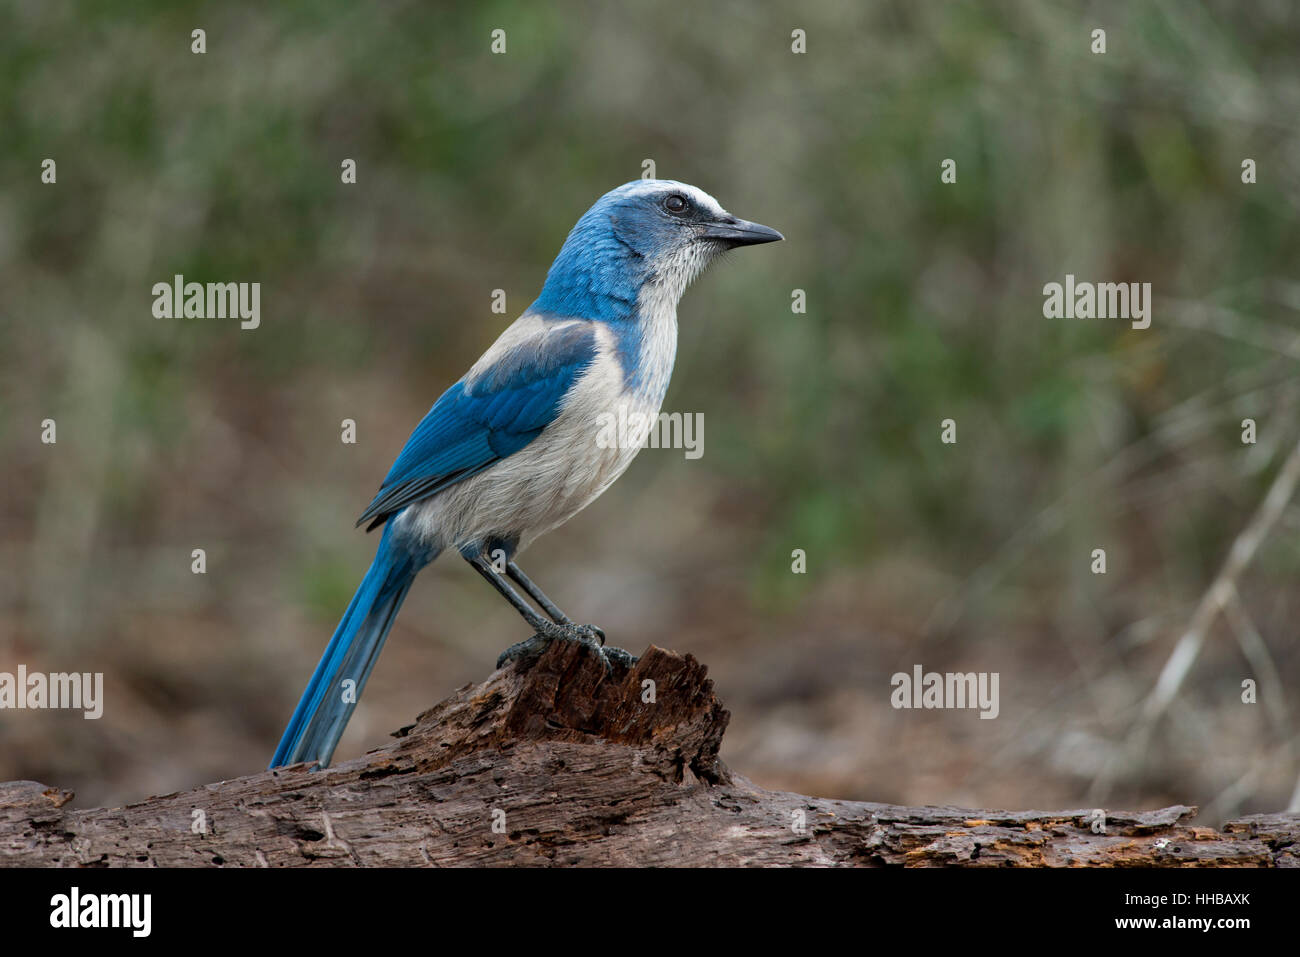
[533,179,784,319]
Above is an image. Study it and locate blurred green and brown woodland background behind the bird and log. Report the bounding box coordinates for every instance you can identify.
[0,0,1300,823]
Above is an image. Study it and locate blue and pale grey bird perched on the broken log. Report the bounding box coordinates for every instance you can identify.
[270,179,784,768]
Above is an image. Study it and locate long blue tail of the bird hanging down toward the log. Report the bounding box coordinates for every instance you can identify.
[270,521,436,767]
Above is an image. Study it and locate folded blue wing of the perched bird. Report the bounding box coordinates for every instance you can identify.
[356,321,597,531]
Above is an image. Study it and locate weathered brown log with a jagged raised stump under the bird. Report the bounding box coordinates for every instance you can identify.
[0,644,1300,867]
